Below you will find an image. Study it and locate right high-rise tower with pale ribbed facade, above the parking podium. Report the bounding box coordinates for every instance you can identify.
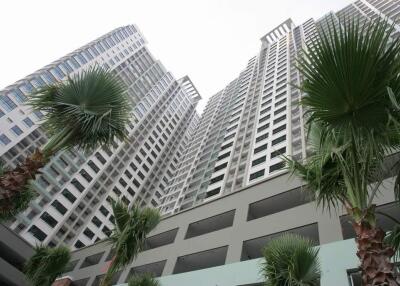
[161,0,400,214]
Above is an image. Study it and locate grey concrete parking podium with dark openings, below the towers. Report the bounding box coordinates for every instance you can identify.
[58,174,399,286]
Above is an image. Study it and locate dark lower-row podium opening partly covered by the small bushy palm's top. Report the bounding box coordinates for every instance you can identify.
[240,223,319,261]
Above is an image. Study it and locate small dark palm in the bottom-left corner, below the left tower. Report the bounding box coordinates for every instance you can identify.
[25,246,71,286]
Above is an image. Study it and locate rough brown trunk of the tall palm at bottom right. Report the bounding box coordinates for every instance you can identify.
[353,221,400,286]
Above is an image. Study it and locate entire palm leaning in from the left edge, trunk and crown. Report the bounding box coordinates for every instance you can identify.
[0,67,130,220]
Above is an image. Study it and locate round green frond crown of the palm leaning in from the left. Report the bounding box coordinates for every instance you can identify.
[28,67,131,154]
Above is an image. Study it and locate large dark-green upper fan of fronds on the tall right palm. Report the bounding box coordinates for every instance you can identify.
[298,20,400,133]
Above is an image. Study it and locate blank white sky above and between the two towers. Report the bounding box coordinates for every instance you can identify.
[0,0,351,114]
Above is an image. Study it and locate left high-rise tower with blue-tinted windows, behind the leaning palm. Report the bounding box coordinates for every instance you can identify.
[0,25,200,248]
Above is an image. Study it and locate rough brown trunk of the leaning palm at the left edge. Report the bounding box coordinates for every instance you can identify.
[0,149,48,213]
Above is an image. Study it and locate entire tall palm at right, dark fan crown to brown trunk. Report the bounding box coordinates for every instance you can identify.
[286,21,400,285]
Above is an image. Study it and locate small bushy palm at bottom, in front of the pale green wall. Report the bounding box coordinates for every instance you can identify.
[262,234,321,286]
